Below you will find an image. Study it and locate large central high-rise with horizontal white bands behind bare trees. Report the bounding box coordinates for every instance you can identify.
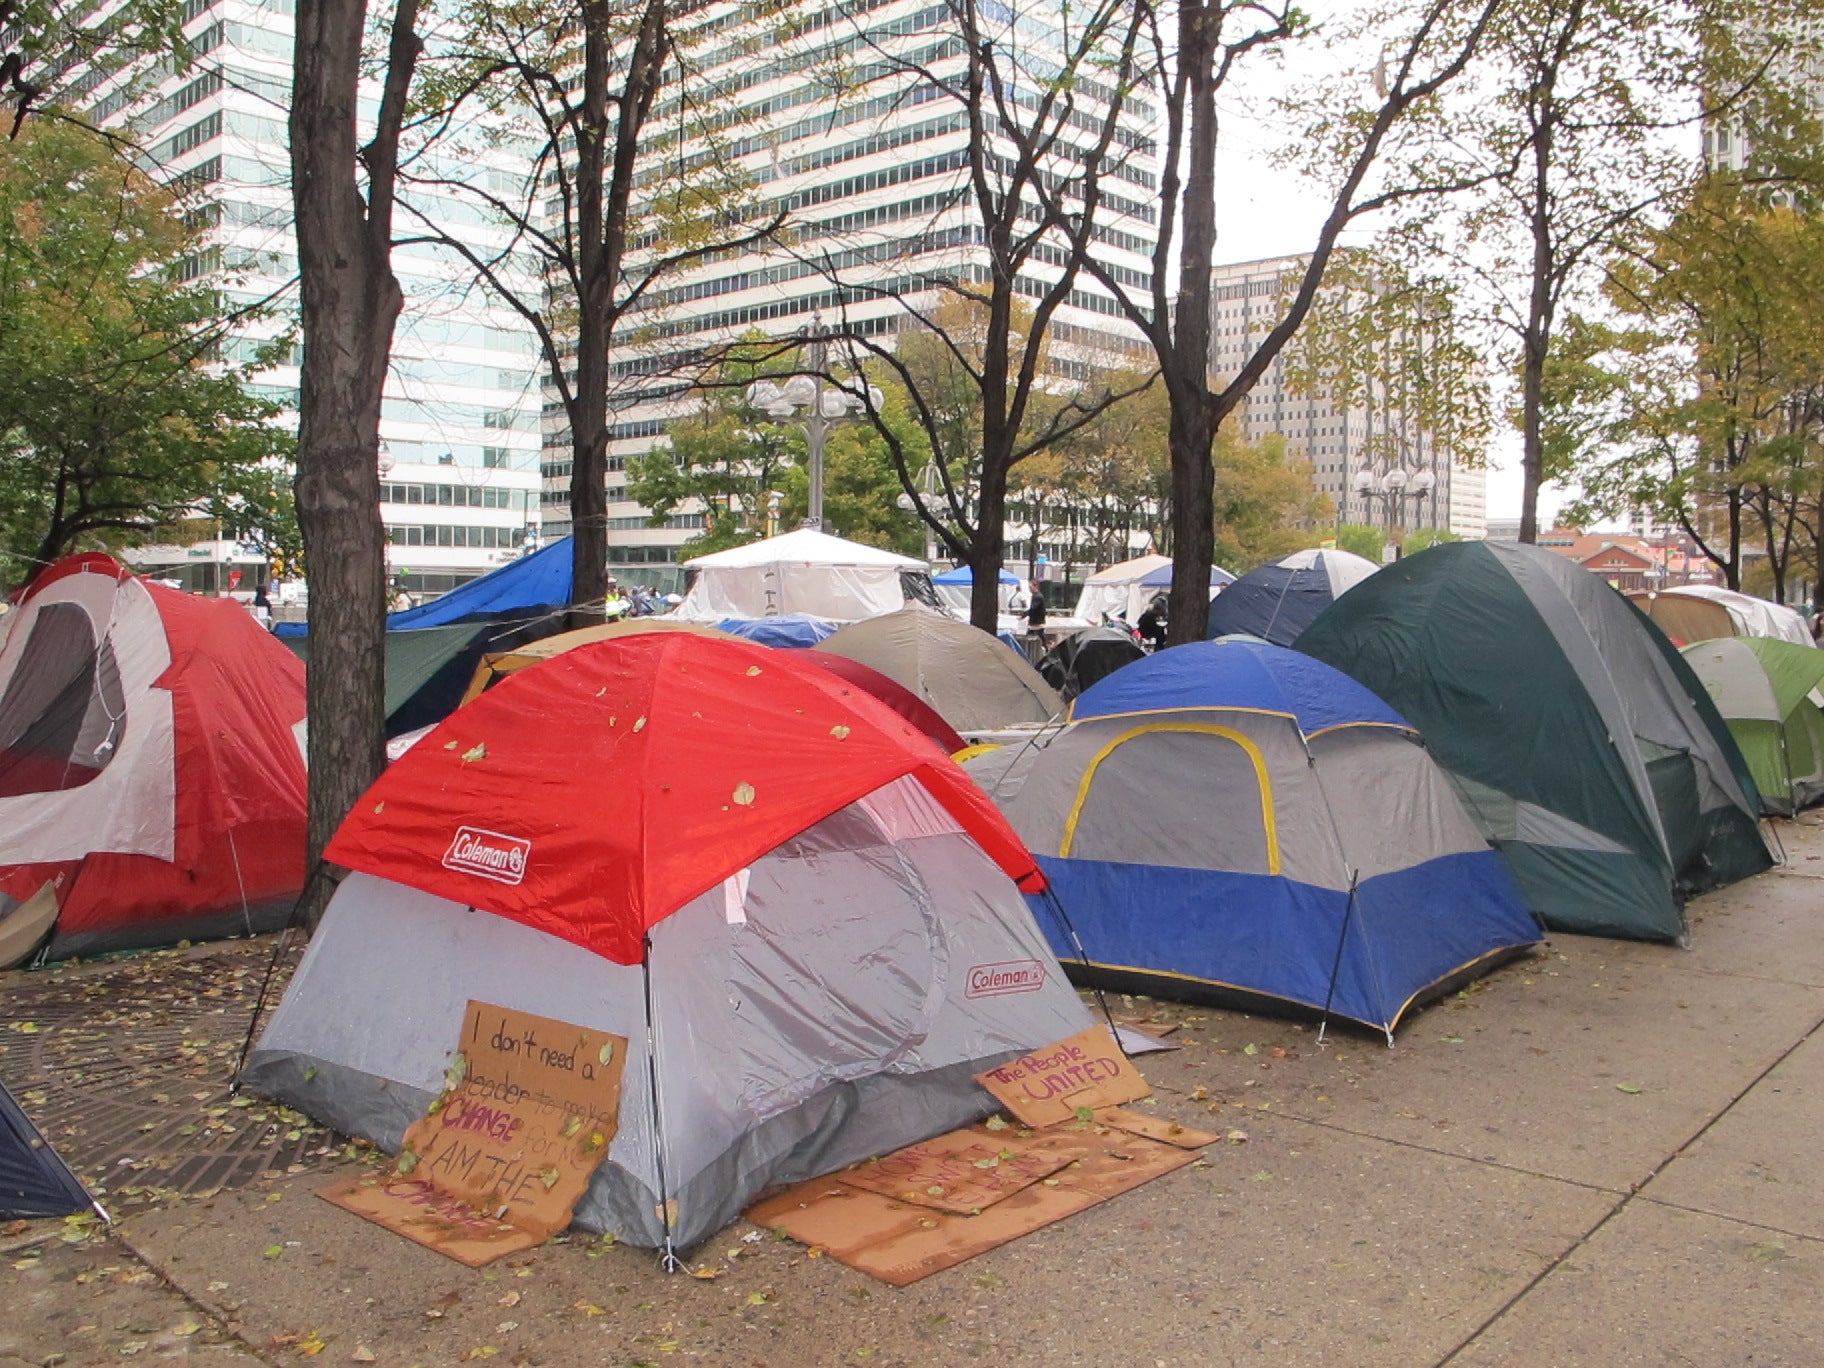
[544,0,1158,569]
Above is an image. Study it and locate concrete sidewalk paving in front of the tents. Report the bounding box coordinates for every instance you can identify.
[0,819,1824,1368]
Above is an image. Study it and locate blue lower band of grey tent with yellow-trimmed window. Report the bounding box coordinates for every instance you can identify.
[1036,852,1538,1029]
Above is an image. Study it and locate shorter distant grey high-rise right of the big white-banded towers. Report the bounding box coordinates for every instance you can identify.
[1209,255,1487,536]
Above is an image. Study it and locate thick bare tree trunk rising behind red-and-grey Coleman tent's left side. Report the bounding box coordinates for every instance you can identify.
[290,0,420,921]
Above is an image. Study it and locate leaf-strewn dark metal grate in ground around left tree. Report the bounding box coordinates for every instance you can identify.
[0,936,332,1207]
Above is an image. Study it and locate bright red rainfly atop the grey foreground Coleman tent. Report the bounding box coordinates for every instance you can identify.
[326,631,1045,965]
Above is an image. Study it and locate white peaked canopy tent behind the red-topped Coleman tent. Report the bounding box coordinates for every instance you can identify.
[677,527,930,622]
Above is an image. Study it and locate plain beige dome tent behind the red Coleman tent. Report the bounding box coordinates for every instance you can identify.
[817,607,1063,731]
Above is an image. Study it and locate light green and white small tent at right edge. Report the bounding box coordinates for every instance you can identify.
[1685,637,1824,817]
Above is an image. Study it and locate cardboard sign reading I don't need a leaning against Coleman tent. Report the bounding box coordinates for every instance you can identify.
[323,1001,627,1266]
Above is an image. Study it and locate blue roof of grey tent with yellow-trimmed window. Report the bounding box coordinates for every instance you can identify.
[1071,642,1406,735]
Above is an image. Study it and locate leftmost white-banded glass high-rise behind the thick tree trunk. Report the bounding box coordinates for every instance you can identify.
[88,0,542,593]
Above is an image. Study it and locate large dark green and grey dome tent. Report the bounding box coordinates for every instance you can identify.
[1299,542,1773,939]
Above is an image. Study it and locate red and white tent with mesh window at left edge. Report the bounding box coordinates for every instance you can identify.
[0,554,305,963]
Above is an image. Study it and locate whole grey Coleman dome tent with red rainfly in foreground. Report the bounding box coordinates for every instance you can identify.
[243,631,1089,1249]
